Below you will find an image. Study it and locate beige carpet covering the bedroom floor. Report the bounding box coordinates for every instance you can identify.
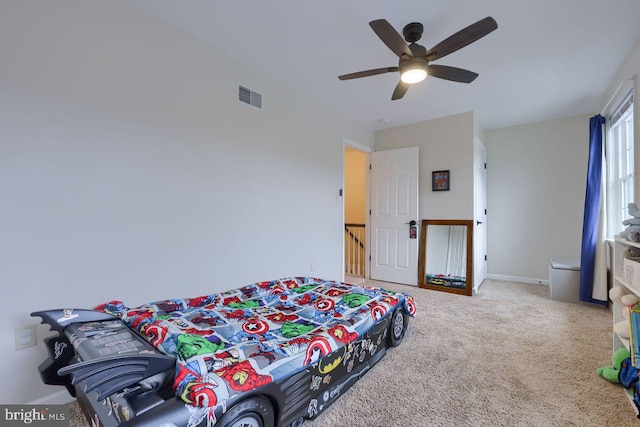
[71,280,640,427]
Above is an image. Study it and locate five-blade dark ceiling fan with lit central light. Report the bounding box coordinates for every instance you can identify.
[338,16,498,101]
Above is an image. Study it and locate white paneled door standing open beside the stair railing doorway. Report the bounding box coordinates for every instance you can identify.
[371,147,419,286]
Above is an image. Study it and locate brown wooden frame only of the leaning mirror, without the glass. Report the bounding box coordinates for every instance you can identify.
[418,219,473,296]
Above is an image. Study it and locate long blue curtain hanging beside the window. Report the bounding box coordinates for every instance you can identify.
[580,114,607,305]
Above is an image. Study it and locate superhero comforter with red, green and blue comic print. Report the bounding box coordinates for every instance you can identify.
[97,277,416,407]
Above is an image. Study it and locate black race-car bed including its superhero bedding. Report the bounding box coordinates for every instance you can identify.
[31,277,416,427]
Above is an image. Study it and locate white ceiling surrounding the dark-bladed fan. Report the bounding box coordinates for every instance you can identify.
[130,0,640,130]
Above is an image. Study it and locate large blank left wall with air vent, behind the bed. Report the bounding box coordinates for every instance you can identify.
[0,0,373,403]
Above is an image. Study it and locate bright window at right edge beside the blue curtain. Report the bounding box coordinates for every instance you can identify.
[606,92,634,238]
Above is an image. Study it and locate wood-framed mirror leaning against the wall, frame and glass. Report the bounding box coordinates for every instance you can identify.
[418,219,473,296]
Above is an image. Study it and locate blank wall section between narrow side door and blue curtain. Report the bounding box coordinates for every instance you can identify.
[485,115,589,283]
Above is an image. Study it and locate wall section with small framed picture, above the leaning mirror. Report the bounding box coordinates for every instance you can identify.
[375,112,474,219]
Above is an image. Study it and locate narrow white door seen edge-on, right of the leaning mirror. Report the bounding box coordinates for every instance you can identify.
[473,139,487,289]
